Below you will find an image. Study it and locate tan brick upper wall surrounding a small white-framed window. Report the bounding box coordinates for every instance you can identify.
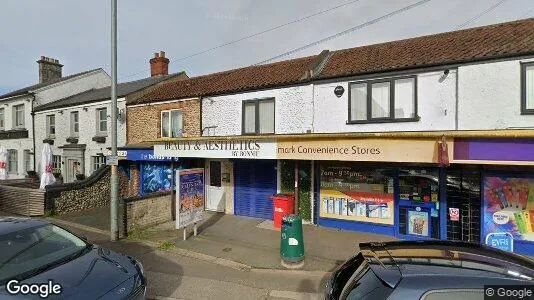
[126,99,201,145]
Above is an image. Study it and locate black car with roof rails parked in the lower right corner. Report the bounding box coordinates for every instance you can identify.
[325,241,534,300]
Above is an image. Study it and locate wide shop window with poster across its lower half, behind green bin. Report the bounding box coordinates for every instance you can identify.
[319,165,394,225]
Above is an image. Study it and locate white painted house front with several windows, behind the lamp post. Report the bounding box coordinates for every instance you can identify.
[35,98,126,178]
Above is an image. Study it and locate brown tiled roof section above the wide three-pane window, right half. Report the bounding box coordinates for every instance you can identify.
[319,18,534,78]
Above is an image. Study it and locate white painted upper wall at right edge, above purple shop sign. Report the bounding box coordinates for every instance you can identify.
[458,59,534,130]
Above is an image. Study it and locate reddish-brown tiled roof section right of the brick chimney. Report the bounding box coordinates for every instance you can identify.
[128,55,317,104]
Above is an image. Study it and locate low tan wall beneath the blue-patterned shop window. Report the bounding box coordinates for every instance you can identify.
[125,192,172,232]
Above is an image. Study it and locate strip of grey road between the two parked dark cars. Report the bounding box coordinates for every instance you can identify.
[58,221,325,299]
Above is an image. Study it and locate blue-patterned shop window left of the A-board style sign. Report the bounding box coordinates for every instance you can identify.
[139,162,172,195]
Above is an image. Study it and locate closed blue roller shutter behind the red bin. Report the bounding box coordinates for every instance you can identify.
[234,160,276,220]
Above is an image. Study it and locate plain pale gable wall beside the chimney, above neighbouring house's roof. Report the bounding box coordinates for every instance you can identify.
[35,70,111,106]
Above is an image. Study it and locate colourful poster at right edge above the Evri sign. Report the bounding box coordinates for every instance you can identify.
[482,176,534,246]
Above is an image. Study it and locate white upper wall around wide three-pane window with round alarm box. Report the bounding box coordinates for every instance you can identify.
[313,70,457,133]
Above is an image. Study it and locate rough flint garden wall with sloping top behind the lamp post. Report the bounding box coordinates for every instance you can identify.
[45,166,128,214]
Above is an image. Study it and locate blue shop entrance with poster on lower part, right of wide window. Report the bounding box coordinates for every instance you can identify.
[398,169,440,239]
